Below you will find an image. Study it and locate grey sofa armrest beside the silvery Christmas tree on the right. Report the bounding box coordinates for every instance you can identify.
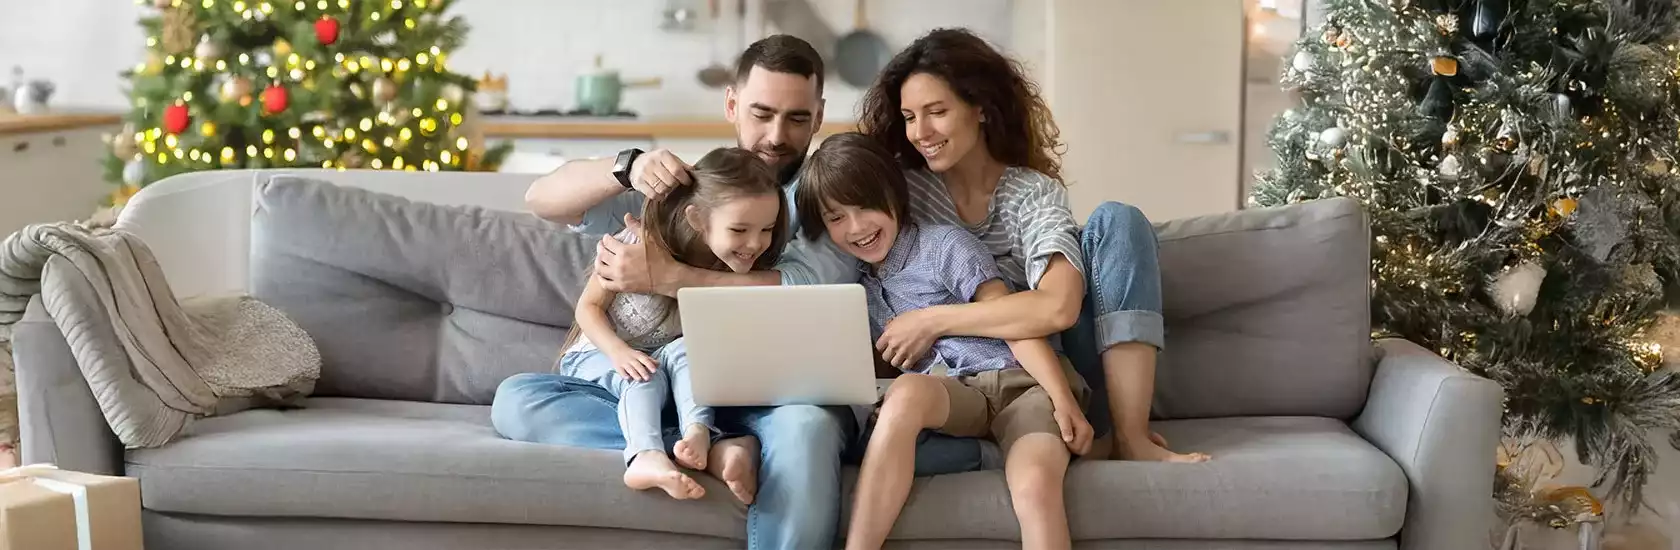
[1354,340,1504,550]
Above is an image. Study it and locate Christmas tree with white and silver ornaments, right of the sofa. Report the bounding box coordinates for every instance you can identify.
[1252,0,1680,526]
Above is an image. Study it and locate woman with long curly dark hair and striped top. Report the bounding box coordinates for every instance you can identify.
[858,29,1208,463]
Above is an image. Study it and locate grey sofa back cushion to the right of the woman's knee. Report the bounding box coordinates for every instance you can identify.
[1156,198,1374,419]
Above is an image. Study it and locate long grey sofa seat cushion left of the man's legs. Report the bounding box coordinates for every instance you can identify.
[128,399,746,538]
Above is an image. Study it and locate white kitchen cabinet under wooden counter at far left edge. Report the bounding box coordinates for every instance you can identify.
[0,124,118,237]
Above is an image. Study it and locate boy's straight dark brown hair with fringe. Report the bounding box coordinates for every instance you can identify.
[793,131,911,239]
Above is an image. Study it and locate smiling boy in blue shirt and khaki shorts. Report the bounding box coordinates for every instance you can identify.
[795,133,1092,548]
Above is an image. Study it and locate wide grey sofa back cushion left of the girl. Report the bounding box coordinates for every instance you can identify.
[250,175,595,404]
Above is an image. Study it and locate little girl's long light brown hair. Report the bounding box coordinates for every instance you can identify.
[642,146,790,271]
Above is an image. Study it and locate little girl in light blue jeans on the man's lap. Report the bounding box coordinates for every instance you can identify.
[559,148,790,503]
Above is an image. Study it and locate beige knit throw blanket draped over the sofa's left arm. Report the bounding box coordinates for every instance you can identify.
[0,222,321,447]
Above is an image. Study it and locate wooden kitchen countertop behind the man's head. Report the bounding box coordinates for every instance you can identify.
[479,116,857,140]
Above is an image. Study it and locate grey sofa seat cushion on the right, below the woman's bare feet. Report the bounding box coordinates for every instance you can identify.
[847,417,1408,540]
